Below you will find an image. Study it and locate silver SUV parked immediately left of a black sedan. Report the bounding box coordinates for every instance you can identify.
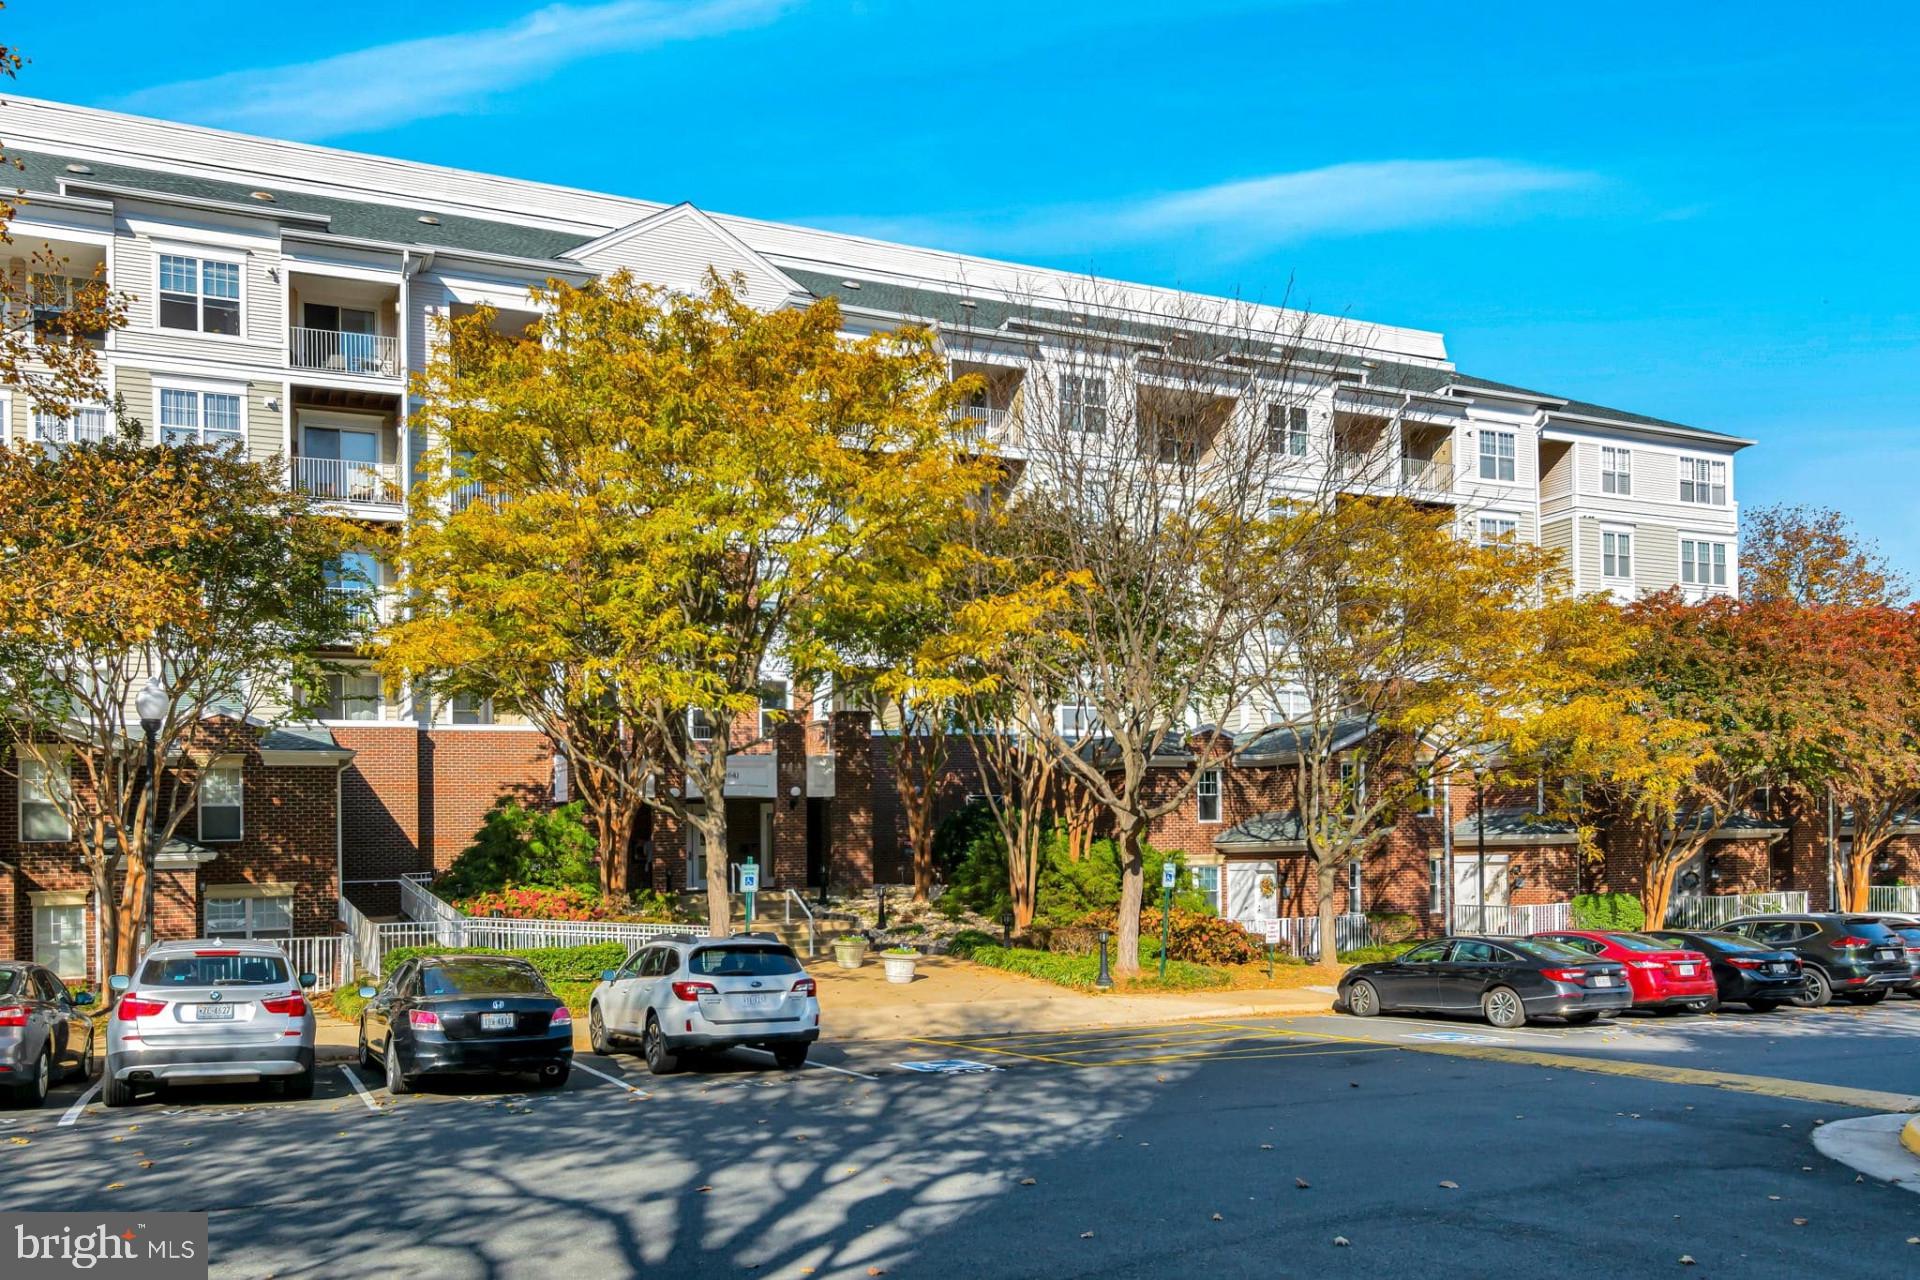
[100,940,313,1107]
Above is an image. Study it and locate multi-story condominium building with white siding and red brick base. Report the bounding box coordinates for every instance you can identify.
[0,98,1889,973]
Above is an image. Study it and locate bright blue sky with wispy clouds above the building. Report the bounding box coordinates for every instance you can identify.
[11,0,1920,578]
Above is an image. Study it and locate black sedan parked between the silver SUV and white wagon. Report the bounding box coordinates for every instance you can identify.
[359,956,574,1094]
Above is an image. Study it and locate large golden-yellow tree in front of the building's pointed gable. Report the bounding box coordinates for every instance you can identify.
[380,273,991,935]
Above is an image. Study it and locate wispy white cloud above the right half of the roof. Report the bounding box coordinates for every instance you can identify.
[822,159,1597,259]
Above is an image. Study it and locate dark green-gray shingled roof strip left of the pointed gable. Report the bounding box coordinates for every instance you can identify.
[8,150,591,259]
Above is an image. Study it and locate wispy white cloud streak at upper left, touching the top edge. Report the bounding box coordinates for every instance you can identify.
[113,0,795,140]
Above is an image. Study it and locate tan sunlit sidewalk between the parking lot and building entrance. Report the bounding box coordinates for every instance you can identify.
[315,954,1332,1063]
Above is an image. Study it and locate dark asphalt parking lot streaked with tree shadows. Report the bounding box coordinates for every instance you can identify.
[0,1002,1920,1276]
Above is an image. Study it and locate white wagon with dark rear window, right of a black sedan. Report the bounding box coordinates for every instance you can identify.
[588,933,820,1075]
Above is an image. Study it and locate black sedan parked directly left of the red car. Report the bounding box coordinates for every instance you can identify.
[1338,936,1634,1029]
